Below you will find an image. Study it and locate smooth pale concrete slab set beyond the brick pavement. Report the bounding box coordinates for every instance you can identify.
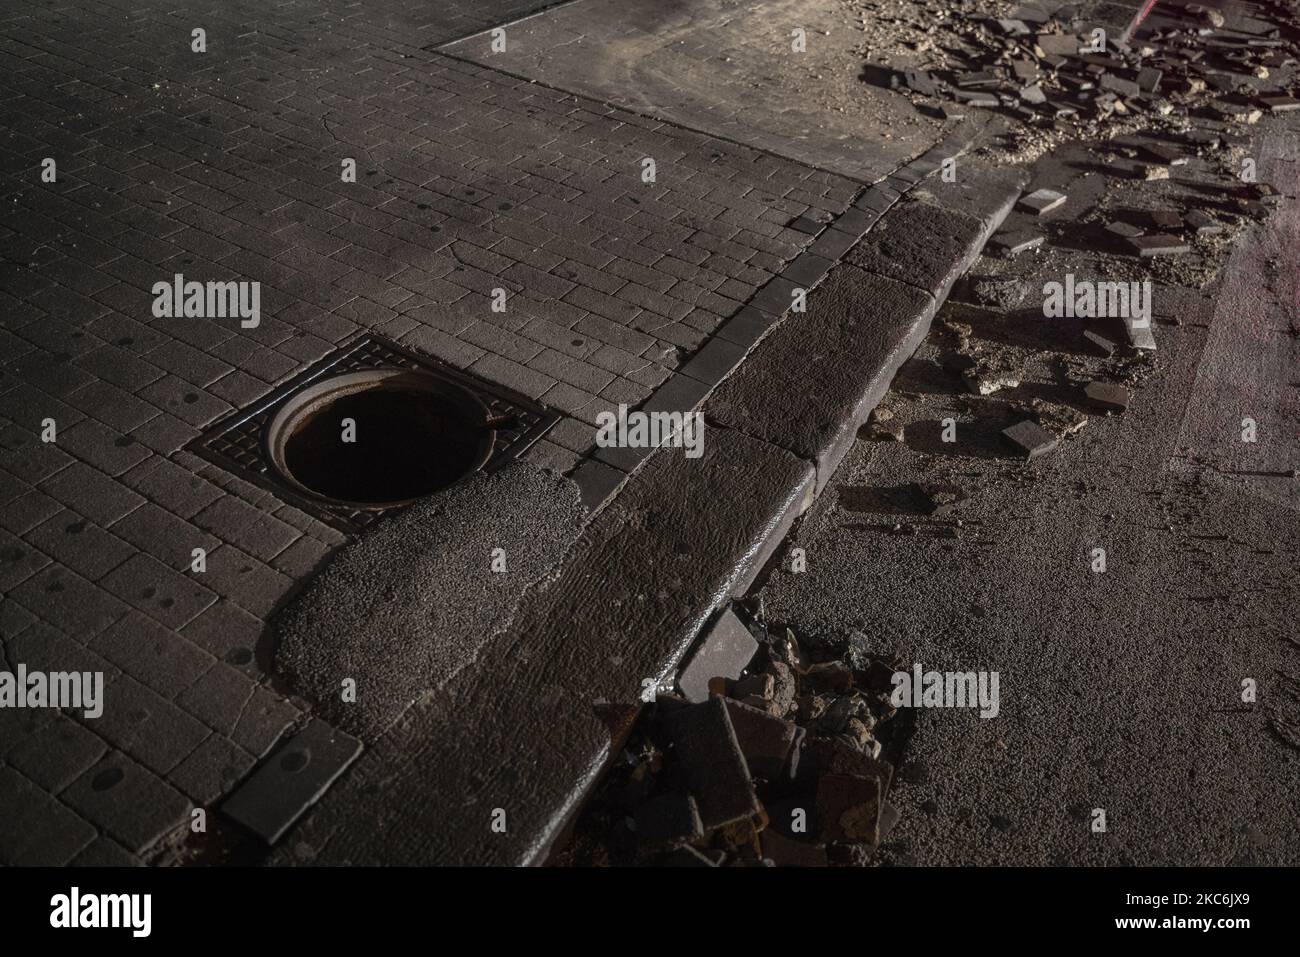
[442,0,941,182]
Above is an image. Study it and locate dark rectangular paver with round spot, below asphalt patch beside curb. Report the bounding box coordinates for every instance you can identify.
[221,718,361,844]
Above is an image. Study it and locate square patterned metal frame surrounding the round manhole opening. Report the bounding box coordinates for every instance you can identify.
[186,333,560,534]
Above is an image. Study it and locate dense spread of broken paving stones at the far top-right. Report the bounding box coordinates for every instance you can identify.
[866,0,1300,149]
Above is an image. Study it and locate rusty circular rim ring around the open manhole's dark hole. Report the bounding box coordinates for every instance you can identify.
[263,368,497,512]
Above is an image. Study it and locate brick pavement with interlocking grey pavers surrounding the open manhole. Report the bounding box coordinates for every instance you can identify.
[0,0,873,863]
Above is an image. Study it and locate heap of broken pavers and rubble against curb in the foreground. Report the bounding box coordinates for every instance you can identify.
[566,610,904,866]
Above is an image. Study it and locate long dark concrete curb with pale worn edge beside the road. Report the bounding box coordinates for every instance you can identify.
[272,164,1023,865]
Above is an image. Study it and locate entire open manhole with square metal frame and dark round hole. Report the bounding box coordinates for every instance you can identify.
[191,337,558,532]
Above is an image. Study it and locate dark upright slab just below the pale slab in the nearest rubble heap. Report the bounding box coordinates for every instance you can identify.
[668,696,763,831]
